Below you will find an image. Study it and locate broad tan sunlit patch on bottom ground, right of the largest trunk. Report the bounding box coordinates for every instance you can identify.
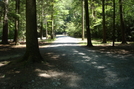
[35,69,81,87]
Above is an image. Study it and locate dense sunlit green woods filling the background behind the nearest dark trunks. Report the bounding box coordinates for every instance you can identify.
[0,0,134,44]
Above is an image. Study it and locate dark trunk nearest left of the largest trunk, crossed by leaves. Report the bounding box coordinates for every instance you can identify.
[14,0,20,44]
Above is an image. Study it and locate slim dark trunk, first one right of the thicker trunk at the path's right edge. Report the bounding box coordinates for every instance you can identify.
[102,0,107,43]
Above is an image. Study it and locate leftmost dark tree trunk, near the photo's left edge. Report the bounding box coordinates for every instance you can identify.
[2,0,8,44]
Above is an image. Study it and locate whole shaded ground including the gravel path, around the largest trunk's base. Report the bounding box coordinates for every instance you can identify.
[0,36,134,89]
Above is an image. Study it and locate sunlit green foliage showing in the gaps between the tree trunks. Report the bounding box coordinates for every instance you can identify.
[0,0,134,40]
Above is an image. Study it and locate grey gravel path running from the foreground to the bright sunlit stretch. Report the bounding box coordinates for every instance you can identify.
[38,36,134,89]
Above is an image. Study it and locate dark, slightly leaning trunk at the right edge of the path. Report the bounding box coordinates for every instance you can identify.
[85,0,93,47]
